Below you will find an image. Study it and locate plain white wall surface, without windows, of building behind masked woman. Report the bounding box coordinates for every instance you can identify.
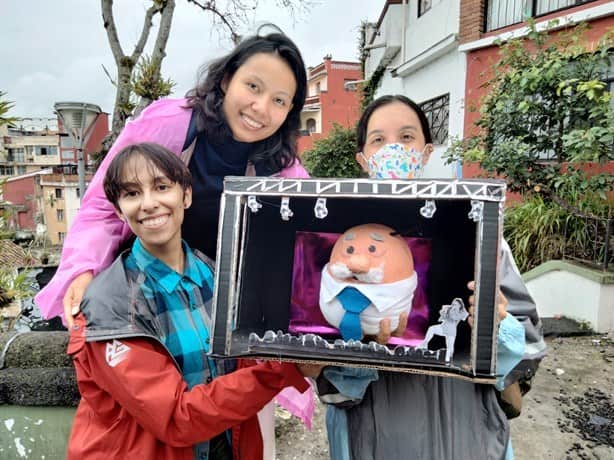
[365,0,467,178]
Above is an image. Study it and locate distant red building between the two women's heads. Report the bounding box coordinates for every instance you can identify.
[298,55,362,153]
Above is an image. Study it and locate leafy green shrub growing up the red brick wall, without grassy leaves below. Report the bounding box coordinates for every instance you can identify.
[447,23,614,204]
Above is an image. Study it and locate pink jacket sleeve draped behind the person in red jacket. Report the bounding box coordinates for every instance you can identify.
[35,100,191,318]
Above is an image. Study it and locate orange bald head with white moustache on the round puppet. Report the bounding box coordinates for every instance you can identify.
[328,224,414,283]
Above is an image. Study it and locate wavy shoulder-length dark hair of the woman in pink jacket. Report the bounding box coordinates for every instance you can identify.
[186,33,307,174]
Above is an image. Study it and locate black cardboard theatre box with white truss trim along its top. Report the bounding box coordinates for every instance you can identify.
[211,177,505,382]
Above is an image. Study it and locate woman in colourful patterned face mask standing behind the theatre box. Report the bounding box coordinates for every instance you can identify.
[317,96,544,460]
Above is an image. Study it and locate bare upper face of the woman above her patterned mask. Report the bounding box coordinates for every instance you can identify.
[356,101,433,172]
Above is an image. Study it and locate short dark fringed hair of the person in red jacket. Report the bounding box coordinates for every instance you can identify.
[103,142,192,209]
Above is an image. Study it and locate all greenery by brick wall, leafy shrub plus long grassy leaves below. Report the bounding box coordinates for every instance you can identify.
[446,22,614,271]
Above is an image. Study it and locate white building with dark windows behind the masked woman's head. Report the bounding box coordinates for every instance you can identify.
[365,0,466,177]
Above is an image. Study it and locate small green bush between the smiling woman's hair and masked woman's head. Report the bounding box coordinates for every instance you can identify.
[303,124,362,177]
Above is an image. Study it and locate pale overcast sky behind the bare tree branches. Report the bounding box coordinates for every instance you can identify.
[0,0,385,117]
